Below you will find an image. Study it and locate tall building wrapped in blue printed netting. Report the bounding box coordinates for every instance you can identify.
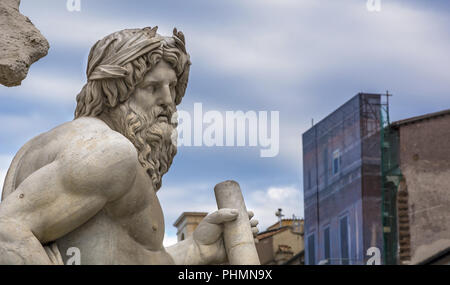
[303,93,383,264]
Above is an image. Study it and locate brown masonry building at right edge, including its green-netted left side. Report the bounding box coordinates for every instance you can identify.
[382,110,450,264]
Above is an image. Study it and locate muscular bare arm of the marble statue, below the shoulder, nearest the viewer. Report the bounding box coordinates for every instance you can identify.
[0,136,136,264]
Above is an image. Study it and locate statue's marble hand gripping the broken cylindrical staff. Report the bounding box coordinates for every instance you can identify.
[194,208,258,264]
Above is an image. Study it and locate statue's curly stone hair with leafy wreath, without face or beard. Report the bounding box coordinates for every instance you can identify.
[75,27,191,119]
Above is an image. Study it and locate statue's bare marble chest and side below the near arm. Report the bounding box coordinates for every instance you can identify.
[57,164,172,264]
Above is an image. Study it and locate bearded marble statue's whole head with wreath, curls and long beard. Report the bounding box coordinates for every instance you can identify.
[75,27,191,190]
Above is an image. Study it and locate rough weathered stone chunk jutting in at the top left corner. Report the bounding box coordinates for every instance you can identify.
[0,0,49,87]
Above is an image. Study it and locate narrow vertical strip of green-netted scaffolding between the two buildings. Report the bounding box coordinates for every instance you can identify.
[380,92,402,265]
